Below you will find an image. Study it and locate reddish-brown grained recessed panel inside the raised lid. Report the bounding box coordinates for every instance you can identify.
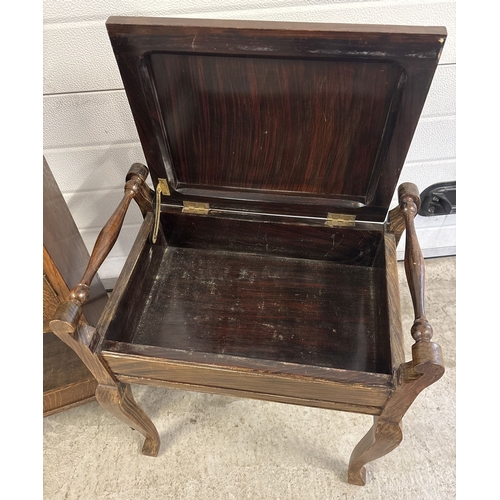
[150,54,401,203]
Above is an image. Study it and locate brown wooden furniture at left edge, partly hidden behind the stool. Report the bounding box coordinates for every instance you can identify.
[43,158,108,417]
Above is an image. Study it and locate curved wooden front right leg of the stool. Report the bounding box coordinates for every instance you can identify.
[348,417,403,486]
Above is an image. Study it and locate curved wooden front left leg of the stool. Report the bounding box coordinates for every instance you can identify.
[95,382,160,457]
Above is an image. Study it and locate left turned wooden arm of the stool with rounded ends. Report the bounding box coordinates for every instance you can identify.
[50,163,148,333]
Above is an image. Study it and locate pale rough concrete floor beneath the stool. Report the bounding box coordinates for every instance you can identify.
[43,257,456,500]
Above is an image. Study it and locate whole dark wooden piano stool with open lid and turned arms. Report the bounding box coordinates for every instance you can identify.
[51,17,446,485]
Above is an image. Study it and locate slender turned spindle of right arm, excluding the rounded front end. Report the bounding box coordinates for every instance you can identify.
[398,182,432,342]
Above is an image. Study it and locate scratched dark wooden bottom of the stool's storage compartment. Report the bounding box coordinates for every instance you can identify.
[102,240,391,373]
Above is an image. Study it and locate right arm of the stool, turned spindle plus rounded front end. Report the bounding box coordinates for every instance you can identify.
[398,182,444,378]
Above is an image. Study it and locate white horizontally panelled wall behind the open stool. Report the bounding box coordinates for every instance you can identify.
[43,0,456,279]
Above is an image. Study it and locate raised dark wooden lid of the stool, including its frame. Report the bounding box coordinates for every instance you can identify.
[107,17,446,222]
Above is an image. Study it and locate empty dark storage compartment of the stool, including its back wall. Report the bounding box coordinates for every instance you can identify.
[105,214,391,373]
